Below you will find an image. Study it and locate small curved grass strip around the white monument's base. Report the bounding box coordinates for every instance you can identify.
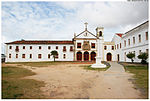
[83,62,110,71]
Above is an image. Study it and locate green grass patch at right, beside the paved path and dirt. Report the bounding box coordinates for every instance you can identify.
[120,64,148,98]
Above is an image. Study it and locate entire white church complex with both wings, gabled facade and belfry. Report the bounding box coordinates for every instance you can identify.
[6,21,149,62]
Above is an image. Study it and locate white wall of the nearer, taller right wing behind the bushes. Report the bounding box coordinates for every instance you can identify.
[122,24,149,62]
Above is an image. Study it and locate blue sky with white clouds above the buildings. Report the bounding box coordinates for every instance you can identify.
[1,1,148,53]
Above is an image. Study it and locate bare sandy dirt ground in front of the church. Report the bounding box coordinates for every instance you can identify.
[3,64,142,99]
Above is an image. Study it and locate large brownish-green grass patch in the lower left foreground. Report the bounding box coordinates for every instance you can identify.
[2,66,44,99]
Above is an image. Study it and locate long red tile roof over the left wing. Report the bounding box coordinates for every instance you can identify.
[6,40,73,44]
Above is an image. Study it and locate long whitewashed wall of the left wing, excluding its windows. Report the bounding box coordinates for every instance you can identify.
[6,44,74,62]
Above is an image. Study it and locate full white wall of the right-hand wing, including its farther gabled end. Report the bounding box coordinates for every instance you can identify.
[112,23,149,62]
